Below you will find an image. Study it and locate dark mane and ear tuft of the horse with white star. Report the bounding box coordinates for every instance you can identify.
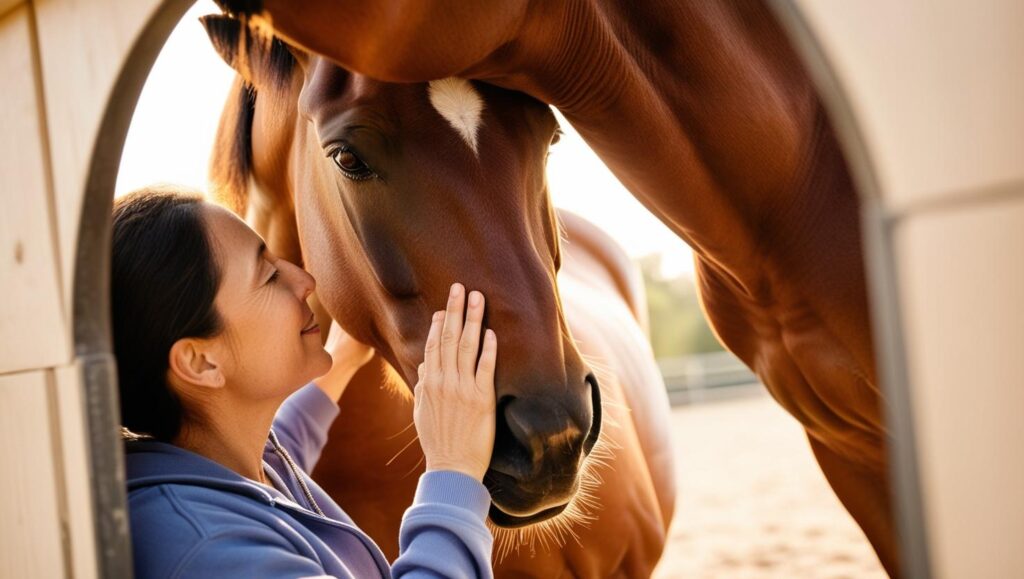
[200,14,297,215]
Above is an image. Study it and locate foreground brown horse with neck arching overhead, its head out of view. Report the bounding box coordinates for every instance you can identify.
[214,0,899,575]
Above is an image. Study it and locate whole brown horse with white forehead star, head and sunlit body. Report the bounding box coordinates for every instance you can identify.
[204,16,674,577]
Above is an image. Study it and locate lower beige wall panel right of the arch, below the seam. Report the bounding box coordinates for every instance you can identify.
[896,197,1024,578]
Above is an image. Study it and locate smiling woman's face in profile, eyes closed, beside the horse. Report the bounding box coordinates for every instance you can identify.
[203,204,331,399]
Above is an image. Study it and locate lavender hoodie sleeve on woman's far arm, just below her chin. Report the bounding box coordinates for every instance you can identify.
[273,382,338,472]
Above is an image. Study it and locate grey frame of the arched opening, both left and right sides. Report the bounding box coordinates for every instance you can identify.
[74,0,927,576]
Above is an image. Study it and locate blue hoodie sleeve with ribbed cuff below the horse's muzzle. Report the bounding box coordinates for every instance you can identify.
[391,470,494,579]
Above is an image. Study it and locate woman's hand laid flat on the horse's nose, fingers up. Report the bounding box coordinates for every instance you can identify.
[413,284,498,481]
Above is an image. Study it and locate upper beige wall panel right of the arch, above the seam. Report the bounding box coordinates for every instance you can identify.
[796,0,1024,211]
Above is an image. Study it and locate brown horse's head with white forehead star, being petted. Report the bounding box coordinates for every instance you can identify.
[205,16,601,527]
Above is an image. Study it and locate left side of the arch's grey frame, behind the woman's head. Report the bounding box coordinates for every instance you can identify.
[73,0,193,577]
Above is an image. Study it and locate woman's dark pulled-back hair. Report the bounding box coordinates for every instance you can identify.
[111,188,221,442]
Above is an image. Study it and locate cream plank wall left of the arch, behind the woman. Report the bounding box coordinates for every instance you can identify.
[0,0,166,578]
